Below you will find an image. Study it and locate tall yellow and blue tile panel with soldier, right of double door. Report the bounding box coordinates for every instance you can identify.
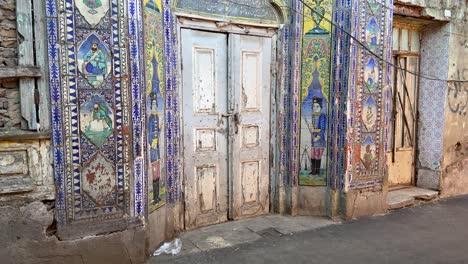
[299,0,333,185]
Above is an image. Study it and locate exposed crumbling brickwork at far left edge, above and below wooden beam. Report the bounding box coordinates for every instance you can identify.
[0,0,21,129]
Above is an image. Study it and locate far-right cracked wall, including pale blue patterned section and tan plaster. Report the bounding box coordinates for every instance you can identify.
[396,0,468,194]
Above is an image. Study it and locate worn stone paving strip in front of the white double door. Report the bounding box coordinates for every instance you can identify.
[153,215,336,263]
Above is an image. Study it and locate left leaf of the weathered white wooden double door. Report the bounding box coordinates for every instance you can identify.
[181,29,228,229]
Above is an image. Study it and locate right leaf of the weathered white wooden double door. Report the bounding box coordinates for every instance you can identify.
[230,35,271,219]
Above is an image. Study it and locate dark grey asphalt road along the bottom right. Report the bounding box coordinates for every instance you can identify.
[149,196,468,264]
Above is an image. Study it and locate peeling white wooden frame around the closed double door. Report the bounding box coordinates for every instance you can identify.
[175,12,282,230]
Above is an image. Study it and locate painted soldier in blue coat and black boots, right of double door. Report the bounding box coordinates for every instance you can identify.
[310,97,327,175]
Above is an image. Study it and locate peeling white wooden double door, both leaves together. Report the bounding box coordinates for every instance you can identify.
[181,29,272,229]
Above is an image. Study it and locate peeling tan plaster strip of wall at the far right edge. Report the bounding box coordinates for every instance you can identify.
[441,4,468,197]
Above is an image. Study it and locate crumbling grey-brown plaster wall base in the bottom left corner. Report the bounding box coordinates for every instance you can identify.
[0,201,146,264]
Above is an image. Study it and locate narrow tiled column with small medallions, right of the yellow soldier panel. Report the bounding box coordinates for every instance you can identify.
[347,0,391,187]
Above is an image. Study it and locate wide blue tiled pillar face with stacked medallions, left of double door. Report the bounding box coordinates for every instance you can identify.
[46,0,135,225]
